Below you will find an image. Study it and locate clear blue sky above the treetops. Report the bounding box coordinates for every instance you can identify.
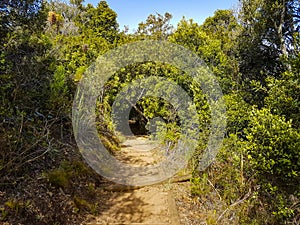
[85,0,238,31]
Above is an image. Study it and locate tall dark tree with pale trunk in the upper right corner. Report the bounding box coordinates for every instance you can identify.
[239,0,299,105]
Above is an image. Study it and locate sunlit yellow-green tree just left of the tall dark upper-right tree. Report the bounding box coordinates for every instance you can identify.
[169,12,239,93]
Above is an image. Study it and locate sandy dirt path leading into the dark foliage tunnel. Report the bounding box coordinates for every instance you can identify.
[88,137,180,225]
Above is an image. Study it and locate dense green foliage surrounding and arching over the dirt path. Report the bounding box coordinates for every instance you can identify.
[0,0,300,225]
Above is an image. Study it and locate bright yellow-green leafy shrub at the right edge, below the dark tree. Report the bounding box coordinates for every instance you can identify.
[246,109,300,181]
